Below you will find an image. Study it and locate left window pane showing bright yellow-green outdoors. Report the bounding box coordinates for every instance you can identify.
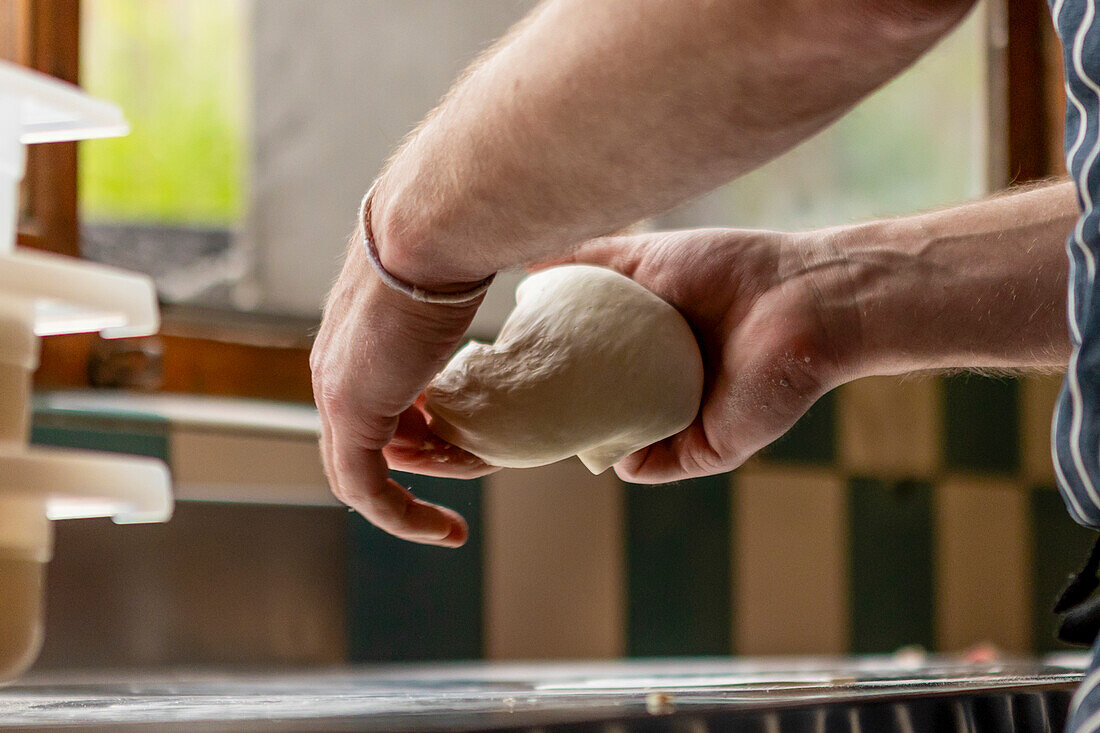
[79,0,250,307]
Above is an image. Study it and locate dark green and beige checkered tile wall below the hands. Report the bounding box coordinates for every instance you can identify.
[35,376,1091,660]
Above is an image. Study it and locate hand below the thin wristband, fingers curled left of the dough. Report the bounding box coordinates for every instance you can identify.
[310,238,493,547]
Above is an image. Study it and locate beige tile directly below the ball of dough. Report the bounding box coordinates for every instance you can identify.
[484,459,626,659]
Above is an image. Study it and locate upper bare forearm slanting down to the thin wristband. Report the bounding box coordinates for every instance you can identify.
[371,0,971,285]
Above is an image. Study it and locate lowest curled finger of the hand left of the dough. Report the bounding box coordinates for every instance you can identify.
[332,436,469,547]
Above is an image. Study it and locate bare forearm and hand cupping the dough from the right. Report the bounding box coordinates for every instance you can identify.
[558,184,1077,483]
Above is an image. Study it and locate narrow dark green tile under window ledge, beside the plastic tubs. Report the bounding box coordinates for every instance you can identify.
[31,412,168,461]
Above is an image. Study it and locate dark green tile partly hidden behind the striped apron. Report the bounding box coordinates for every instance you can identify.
[1031,486,1097,652]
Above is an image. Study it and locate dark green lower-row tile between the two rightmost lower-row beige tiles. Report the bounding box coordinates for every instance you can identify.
[848,478,935,654]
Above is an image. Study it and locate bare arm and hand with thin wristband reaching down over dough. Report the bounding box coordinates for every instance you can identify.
[310,0,972,546]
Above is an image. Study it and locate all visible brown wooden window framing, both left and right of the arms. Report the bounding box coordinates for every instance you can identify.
[0,0,1065,402]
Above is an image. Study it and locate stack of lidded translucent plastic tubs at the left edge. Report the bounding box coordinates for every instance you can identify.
[0,62,173,681]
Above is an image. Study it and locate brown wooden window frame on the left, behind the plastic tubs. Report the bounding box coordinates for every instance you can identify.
[0,0,316,402]
